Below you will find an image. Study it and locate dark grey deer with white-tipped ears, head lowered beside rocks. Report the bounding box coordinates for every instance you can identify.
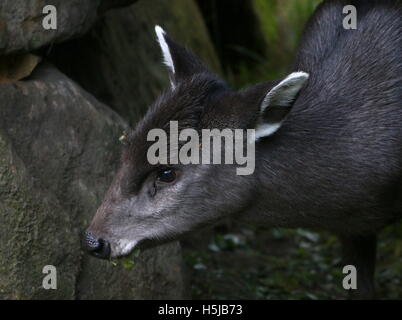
[84,0,402,299]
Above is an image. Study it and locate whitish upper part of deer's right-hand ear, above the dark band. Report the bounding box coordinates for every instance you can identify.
[260,71,309,113]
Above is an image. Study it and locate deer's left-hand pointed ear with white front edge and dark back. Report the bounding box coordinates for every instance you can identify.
[155,25,208,89]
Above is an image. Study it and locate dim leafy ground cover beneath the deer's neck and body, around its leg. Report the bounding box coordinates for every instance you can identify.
[185,225,402,300]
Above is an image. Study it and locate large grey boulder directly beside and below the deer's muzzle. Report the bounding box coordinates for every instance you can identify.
[0,65,184,299]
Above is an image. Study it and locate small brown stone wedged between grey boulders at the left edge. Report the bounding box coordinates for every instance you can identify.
[0,53,41,82]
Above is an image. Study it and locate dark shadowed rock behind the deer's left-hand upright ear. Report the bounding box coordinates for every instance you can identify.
[50,0,221,124]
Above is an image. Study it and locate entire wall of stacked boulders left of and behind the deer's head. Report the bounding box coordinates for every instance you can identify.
[0,0,220,299]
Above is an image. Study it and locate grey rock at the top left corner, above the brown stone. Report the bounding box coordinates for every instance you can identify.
[0,0,135,54]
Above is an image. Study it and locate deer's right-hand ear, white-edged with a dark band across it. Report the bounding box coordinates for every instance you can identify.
[255,71,309,140]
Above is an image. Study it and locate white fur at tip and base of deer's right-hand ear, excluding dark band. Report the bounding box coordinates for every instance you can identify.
[255,71,309,140]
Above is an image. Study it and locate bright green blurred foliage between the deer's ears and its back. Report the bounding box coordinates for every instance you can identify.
[228,0,321,88]
